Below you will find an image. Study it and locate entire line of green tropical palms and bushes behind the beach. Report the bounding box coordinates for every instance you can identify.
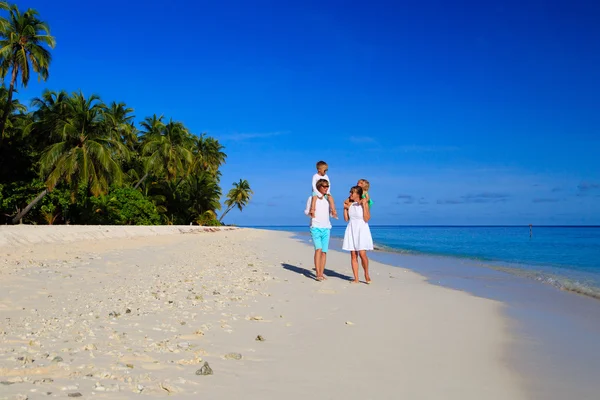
[0,1,253,225]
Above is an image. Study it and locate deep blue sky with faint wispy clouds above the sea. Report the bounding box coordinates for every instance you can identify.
[9,0,600,225]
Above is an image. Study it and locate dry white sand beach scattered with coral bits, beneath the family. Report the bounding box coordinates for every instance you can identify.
[0,226,525,400]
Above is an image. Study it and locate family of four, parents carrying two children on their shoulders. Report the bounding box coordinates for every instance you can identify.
[304,161,373,284]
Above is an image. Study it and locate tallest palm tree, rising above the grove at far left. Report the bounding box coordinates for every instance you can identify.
[0,5,56,141]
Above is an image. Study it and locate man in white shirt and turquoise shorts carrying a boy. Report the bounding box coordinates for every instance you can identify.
[304,179,331,281]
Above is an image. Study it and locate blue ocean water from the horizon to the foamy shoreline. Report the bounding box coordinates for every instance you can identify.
[255,226,600,299]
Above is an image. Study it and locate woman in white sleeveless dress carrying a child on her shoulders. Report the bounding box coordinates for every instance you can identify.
[342,186,373,283]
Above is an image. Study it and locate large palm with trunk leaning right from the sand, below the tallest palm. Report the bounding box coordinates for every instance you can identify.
[13,92,129,223]
